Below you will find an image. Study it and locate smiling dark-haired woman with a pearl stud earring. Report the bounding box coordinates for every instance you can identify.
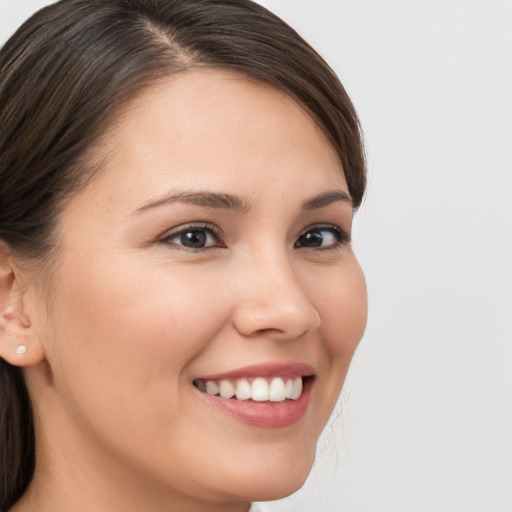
[0,0,366,512]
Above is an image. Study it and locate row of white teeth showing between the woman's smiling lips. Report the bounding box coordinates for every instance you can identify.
[194,376,314,403]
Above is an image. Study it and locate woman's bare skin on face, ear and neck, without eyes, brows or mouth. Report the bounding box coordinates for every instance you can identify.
[1,70,367,512]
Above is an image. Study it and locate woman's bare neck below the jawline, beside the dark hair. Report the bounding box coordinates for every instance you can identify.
[9,418,250,512]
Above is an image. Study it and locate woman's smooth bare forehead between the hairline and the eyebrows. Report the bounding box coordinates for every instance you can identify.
[78,69,346,207]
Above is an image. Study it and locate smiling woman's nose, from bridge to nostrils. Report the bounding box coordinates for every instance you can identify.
[233,251,320,340]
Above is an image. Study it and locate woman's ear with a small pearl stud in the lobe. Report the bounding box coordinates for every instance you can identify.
[0,241,44,366]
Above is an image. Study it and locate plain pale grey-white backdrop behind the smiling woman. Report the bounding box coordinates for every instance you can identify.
[0,0,512,512]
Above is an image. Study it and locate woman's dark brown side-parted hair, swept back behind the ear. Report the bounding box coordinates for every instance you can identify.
[0,0,366,510]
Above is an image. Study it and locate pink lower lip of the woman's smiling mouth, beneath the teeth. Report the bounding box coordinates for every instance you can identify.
[197,379,313,428]
